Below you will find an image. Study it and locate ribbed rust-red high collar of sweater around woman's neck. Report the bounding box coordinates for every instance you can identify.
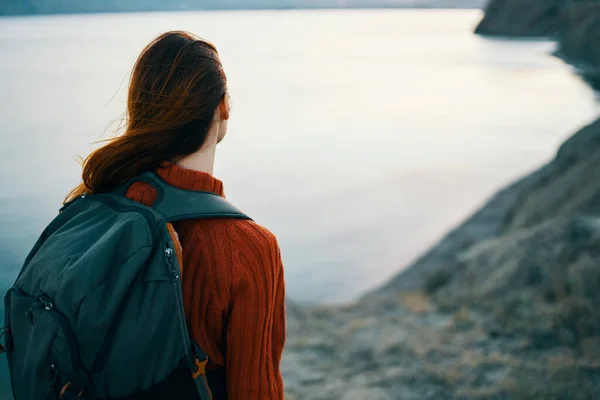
[154,161,225,197]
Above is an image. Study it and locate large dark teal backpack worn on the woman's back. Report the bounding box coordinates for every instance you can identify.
[0,172,250,400]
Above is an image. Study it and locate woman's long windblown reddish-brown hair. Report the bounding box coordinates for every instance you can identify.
[65,31,227,202]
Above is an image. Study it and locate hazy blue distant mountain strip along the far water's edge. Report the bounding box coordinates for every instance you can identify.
[0,0,486,16]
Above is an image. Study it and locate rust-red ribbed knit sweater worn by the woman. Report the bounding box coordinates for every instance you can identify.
[127,163,285,400]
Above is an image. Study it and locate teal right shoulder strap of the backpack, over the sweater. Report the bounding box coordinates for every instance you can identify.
[114,171,251,222]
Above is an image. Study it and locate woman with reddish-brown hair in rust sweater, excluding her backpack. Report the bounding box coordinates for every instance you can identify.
[66,32,285,400]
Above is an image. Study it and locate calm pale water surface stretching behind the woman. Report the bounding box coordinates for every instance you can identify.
[0,10,597,301]
